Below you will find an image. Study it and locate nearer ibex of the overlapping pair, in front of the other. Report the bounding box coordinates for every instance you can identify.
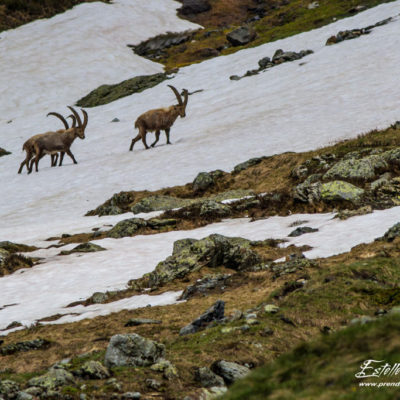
[28,106,88,173]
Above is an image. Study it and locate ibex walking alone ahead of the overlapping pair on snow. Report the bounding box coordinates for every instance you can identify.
[129,85,188,151]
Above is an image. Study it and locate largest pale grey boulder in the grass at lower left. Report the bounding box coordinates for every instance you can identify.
[104,333,165,368]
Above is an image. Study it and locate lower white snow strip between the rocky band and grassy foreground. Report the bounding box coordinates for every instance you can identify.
[0,207,400,329]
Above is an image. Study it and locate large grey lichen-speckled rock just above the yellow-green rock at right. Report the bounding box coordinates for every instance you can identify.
[324,155,389,181]
